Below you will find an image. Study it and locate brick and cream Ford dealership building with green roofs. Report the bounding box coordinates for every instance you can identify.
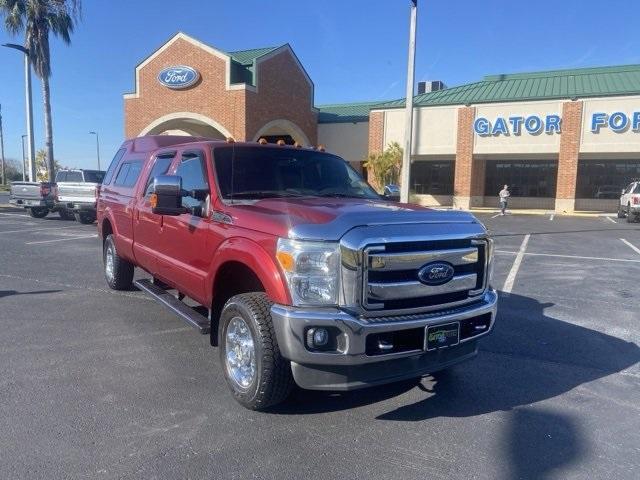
[124,33,640,212]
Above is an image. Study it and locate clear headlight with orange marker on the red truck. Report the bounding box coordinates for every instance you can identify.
[276,238,340,306]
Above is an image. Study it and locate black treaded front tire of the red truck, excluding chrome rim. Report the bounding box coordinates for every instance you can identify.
[218,292,294,410]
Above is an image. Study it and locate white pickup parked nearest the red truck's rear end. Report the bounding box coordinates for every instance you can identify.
[55,169,105,223]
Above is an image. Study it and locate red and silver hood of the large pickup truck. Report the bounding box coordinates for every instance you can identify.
[229,197,478,241]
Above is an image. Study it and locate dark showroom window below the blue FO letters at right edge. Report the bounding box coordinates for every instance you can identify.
[576,160,640,199]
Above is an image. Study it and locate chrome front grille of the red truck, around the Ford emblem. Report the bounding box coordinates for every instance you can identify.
[362,239,487,311]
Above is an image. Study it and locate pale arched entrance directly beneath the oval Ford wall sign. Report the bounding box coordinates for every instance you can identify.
[140,112,231,140]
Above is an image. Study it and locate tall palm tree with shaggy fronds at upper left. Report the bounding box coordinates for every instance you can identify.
[0,0,81,181]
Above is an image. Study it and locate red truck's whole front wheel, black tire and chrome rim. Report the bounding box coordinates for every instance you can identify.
[218,292,294,410]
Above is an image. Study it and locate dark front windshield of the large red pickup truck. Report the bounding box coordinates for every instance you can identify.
[214,147,380,199]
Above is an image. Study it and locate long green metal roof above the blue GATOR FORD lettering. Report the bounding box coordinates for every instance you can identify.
[376,65,640,109]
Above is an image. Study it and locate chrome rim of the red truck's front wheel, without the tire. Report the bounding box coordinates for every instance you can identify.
[225,317,256,390]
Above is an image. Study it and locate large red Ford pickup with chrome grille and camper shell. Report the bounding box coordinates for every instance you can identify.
[98,136,497,409]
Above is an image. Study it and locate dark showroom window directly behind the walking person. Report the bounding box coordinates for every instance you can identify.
[484,160,558,198]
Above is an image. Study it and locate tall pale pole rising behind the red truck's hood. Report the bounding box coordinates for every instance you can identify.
[400,0,418,203]
